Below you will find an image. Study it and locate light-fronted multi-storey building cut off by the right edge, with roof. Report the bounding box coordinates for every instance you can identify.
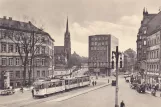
[146,12,161,84]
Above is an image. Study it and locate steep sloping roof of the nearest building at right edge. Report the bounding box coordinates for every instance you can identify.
[147,12,161,35]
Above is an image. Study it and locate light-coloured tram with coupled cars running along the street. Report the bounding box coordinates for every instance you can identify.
[33,76,91,97]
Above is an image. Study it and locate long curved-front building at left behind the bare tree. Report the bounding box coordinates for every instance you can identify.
[0,17,54,88]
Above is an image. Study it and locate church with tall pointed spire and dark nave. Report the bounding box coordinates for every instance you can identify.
[54,18,71,69]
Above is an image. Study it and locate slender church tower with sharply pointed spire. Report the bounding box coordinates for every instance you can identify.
[64,17,71,63]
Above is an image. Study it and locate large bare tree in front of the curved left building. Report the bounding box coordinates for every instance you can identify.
[6,27,42,85]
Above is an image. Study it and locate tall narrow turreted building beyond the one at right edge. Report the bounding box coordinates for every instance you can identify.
[136,8,157,70]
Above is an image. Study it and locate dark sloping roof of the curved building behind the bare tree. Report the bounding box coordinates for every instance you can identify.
[0,17,55,42]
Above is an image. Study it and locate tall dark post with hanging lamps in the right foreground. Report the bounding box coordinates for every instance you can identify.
[112,46,122,107]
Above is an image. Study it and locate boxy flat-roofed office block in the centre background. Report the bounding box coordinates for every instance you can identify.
[88,34,118,75]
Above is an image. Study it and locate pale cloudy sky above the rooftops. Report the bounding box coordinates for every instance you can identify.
[0,0,161,56]
